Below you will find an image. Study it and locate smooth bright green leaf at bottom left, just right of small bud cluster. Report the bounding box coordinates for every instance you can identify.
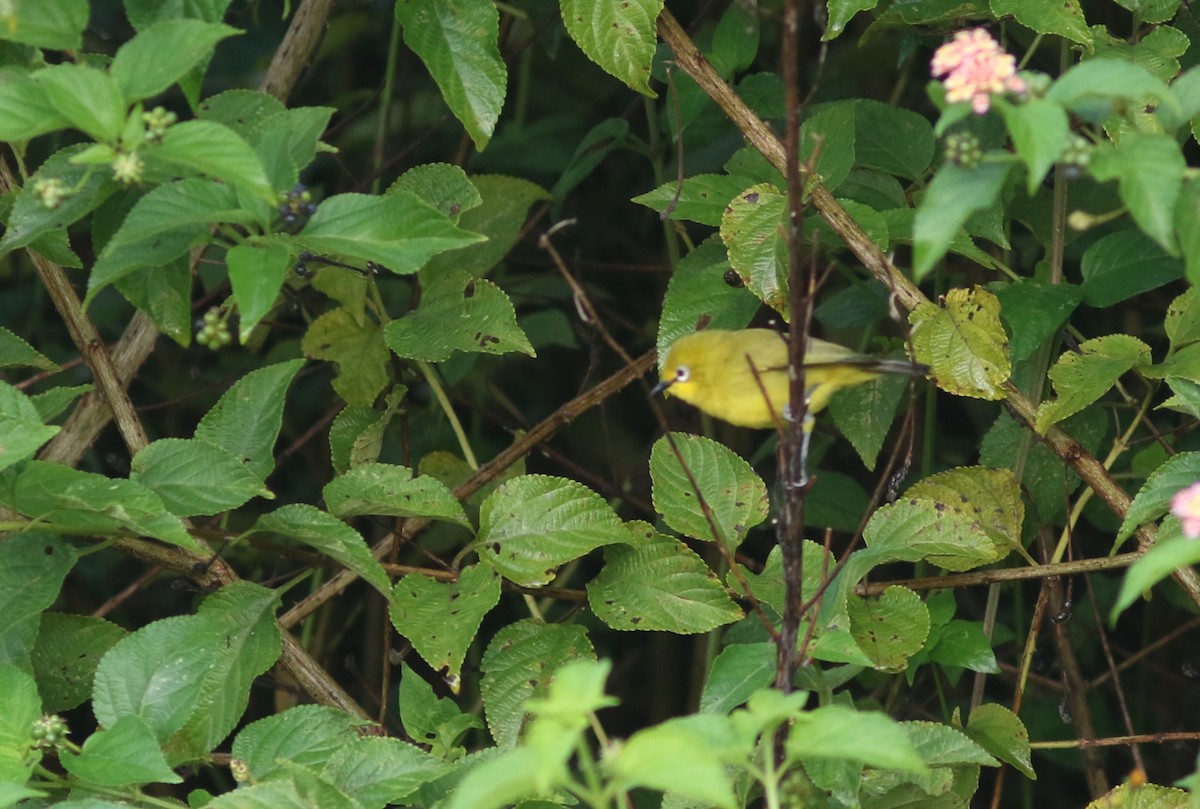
[59,715,184,786]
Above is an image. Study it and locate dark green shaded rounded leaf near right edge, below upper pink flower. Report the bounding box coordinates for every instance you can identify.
[1080,230,1183,307]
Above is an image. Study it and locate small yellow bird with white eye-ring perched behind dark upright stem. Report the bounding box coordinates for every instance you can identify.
[654,329,929,431]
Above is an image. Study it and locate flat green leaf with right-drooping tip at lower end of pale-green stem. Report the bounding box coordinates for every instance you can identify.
[322,463,470,527]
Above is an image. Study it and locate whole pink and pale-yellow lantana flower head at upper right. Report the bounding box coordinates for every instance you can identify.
[932,28,1026,115]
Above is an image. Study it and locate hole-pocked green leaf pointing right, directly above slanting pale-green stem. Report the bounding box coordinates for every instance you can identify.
[384,272,536,362]
